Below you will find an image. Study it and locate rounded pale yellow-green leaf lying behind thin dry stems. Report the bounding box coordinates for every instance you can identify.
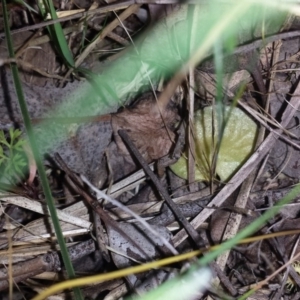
[171,106,257,181]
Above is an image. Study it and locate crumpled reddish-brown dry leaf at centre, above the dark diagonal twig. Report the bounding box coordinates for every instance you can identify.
[112,93,177,162]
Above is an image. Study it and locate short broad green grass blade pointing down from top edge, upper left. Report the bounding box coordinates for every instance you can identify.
[38,0,75,68]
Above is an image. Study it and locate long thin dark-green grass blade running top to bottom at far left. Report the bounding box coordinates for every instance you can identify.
[2,0,83,300]
